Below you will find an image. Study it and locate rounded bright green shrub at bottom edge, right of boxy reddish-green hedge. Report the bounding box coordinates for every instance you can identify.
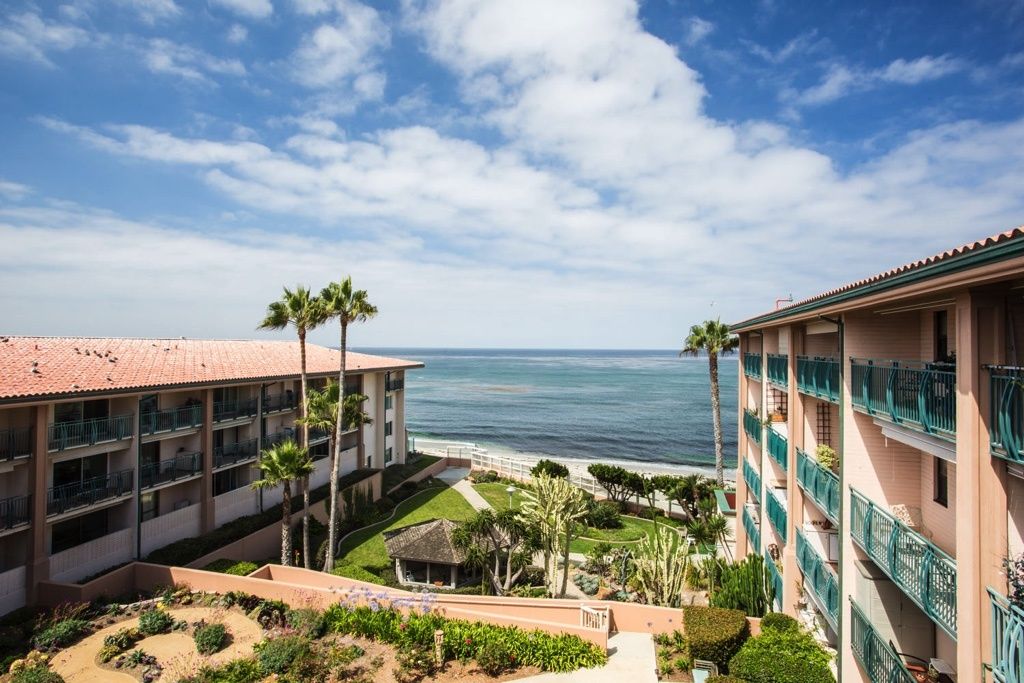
[729,630,836,683]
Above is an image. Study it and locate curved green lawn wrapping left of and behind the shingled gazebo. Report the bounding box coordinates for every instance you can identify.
[336,487,473,573]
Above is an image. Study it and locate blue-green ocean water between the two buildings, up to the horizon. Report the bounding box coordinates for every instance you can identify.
[358,348,738,467]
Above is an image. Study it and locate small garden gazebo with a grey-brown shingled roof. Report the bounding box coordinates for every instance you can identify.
[384,519,476,588]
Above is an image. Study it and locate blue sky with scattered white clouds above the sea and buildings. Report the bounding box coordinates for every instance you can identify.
[0,0,1024,348]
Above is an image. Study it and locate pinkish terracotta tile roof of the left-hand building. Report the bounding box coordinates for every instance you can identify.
[0,337,423,399]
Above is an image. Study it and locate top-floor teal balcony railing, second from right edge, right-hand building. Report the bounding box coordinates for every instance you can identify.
[850,358,956,439]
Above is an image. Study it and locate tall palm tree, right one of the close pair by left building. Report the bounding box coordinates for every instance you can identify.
[319,278,377,571]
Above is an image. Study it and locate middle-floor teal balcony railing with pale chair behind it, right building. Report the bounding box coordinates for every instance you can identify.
[850,488,956,639]
